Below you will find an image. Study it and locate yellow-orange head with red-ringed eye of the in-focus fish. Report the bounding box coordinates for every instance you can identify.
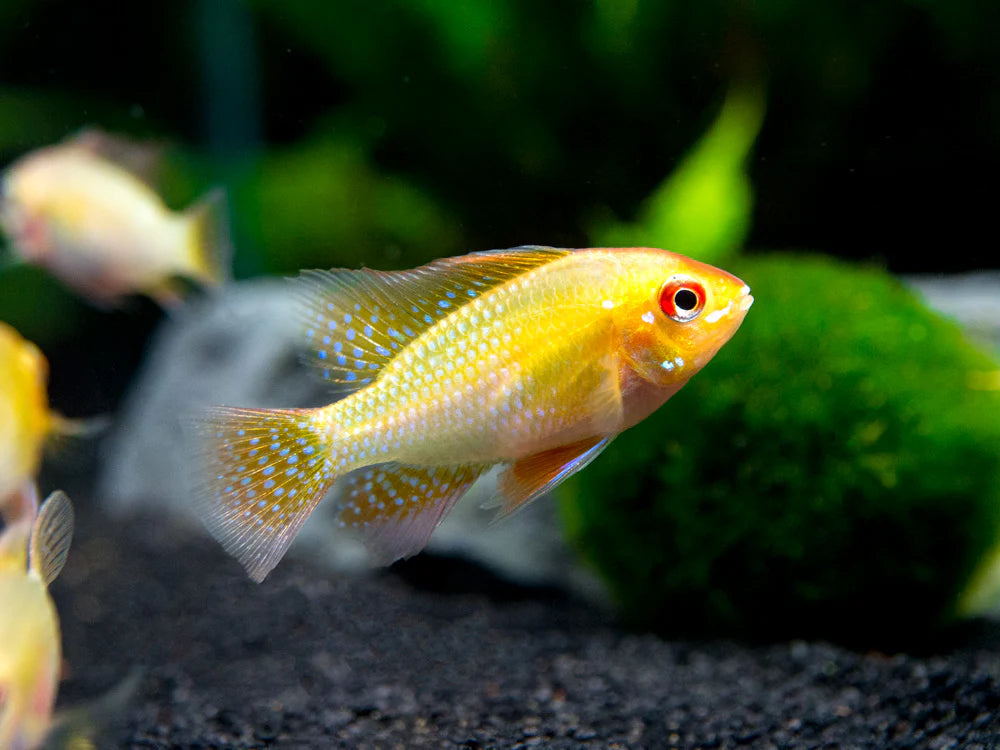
[614,248,753,387]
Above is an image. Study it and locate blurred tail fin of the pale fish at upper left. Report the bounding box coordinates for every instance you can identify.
[182,188,232,287]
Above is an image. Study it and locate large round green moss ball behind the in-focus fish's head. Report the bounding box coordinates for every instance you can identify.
[561,256,1000,639]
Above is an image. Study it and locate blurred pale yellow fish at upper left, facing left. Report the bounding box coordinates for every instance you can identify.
[0,131,228,305]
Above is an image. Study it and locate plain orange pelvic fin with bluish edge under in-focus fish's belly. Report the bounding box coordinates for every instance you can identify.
[497,437,611,518]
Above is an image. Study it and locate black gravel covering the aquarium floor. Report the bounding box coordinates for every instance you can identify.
[53,514,1000,750]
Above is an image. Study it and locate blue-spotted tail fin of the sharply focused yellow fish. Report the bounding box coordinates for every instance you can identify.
[198,407,335,583]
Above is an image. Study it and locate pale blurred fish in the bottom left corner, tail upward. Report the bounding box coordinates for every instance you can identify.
[0,492,73,750]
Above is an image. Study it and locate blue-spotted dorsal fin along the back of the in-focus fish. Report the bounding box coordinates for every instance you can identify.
[298,247,572,400]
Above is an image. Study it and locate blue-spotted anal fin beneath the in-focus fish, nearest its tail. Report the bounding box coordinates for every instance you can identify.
[340,463,489,565]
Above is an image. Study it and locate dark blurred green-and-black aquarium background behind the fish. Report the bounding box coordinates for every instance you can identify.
[0,0,1000,414]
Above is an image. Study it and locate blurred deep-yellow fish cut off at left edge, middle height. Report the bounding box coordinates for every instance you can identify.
[0,322,51,509]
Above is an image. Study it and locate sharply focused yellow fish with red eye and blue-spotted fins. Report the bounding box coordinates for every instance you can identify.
[200,247,753,581]
